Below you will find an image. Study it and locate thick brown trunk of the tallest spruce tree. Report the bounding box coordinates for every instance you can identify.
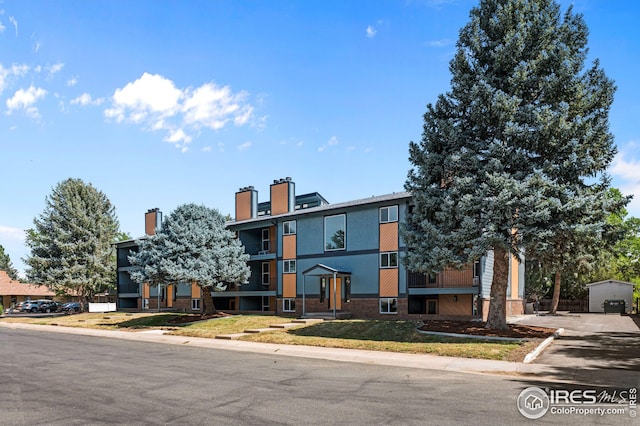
[486,247,509,330]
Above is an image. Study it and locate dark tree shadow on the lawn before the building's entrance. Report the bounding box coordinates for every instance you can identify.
[288,320,514,345]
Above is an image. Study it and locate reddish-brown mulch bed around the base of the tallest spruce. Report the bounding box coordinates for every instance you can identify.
[420,320,556,339]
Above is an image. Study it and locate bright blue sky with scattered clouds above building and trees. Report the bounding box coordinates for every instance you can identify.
[0,0,640,278]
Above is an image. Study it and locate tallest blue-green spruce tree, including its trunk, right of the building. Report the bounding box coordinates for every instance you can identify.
[403,0,615,328]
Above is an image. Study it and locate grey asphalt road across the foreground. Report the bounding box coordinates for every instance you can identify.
[0,328,630,425]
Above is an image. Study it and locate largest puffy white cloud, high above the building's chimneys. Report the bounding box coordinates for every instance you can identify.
[104,73,254,151]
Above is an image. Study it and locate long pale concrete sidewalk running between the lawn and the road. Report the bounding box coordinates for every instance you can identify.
[0,322,640,387]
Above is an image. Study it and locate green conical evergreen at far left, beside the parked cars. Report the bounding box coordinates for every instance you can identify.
[25,179,119,305]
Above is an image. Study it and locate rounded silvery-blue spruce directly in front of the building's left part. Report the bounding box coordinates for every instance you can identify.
[129,204,251,315]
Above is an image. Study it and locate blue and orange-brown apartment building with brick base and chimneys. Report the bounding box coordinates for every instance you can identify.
[118,178,524,319]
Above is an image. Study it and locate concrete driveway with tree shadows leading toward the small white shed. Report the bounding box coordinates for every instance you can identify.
[512,313,640,374]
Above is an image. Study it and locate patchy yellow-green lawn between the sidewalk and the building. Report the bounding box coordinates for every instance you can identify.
[0,312,538,361]
